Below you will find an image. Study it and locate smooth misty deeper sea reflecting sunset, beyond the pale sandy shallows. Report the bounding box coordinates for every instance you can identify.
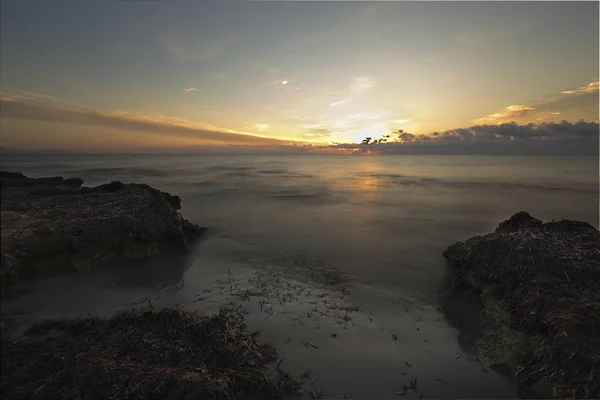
[2,155,598,295]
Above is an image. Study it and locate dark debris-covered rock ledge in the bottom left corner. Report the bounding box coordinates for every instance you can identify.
[0,309,299,400]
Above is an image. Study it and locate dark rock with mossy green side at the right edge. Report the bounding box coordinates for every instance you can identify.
[444,212,600,398]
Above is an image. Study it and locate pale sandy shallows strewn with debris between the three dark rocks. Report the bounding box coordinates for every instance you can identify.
[1,234,516,398]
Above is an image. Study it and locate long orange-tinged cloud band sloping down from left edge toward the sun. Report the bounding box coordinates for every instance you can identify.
[0,95,298,145]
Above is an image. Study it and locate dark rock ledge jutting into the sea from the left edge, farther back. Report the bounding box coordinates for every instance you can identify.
[0,171,204,294]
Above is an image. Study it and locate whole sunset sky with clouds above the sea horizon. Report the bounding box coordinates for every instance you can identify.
[0,0,599,152]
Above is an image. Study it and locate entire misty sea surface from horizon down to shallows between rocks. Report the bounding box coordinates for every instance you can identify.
[0,155,599,398]
